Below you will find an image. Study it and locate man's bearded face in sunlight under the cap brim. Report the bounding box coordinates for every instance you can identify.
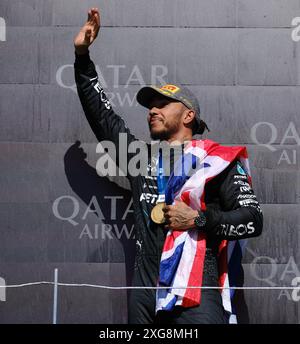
[147,96,187,141]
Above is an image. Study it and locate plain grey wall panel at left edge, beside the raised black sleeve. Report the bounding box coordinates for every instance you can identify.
[0,85,82,143]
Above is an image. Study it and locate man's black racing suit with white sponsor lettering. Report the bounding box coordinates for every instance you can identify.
[75,54,263,324]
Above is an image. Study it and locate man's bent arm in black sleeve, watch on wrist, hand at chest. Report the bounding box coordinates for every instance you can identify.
[164,162,263,240]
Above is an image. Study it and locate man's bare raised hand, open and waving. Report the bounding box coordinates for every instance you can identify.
[74,8,100,55]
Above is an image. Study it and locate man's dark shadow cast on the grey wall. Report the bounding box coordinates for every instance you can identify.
[64,141,135,285]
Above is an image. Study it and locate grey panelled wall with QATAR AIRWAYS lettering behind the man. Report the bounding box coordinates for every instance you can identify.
[0,0,300,323]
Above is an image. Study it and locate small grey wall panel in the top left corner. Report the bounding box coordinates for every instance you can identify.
[0,0,52,27]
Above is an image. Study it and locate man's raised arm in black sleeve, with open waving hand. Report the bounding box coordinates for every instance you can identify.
[74,8,135,157]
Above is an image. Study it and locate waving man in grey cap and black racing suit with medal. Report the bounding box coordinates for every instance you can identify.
[74,8,263,324]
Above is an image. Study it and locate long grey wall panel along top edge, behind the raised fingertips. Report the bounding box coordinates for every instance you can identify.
[54,0,236,27]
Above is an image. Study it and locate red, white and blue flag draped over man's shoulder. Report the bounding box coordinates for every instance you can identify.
[156,140,251,323]
